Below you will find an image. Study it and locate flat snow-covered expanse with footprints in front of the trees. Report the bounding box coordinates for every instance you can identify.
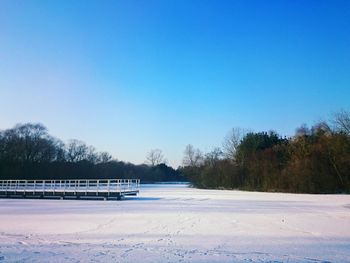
[0,185,350,262]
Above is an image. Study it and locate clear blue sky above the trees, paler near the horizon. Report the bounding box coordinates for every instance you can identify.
[0,0,350,166]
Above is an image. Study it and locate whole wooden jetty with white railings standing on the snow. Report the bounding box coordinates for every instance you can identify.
[0,179,140,200]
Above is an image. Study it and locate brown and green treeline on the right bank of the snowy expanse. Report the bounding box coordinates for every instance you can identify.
[181,111,350,193]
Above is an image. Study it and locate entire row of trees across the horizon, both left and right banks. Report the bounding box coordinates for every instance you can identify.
[0,111,350,193]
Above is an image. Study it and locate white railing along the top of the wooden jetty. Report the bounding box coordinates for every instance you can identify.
[0,179,140,196]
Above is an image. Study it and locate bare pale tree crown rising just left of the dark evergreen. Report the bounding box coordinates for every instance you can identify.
[222,127,248,161]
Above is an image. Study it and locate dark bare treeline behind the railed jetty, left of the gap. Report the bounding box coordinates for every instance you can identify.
[0,123,184,182]
